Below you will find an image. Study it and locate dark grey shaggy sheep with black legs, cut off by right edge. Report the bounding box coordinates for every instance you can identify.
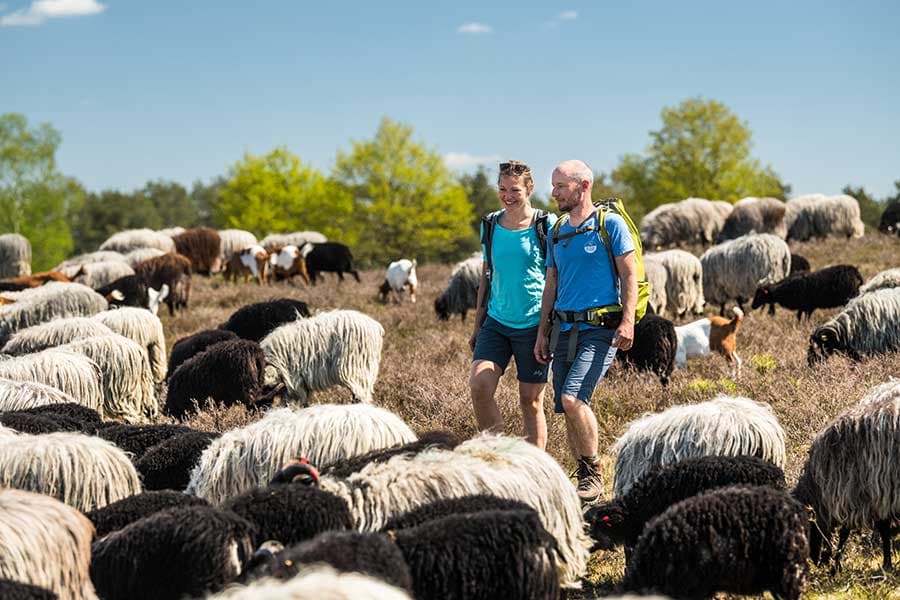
[794,381,900,571]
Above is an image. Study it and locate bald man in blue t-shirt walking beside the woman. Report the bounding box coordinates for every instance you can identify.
[534,160,637,502]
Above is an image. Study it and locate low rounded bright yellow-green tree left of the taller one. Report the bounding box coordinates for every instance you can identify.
[212,147,360,246]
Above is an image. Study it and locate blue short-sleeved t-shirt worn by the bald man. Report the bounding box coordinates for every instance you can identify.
[547,211,634,331]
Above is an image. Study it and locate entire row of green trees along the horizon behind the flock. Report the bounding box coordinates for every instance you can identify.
[0,98,900,270]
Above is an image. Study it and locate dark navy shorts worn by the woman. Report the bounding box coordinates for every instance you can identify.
[472,317,549,383]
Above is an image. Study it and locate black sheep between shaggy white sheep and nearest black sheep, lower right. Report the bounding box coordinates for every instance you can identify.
[584,456,784,557]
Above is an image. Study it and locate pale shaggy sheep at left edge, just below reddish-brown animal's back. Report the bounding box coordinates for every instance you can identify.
[0,281,108,344]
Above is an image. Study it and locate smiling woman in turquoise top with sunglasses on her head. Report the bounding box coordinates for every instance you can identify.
[469,161,556,448]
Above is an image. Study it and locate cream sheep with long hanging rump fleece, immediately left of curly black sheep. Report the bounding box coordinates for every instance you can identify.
[58,333,159,423]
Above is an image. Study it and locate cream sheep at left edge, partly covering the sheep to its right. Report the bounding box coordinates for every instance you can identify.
[0,348,103,413]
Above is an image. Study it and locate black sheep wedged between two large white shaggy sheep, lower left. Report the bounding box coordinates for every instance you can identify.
[134,431,219,491]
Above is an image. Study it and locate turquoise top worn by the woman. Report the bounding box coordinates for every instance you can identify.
[481,211,556,329]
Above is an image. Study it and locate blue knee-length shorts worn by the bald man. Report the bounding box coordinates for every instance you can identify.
[553,327,616,413]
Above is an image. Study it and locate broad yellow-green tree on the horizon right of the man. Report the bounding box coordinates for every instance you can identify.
[612,98,790,210]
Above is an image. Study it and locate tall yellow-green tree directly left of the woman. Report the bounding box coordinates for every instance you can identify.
[334,117,478,265]
